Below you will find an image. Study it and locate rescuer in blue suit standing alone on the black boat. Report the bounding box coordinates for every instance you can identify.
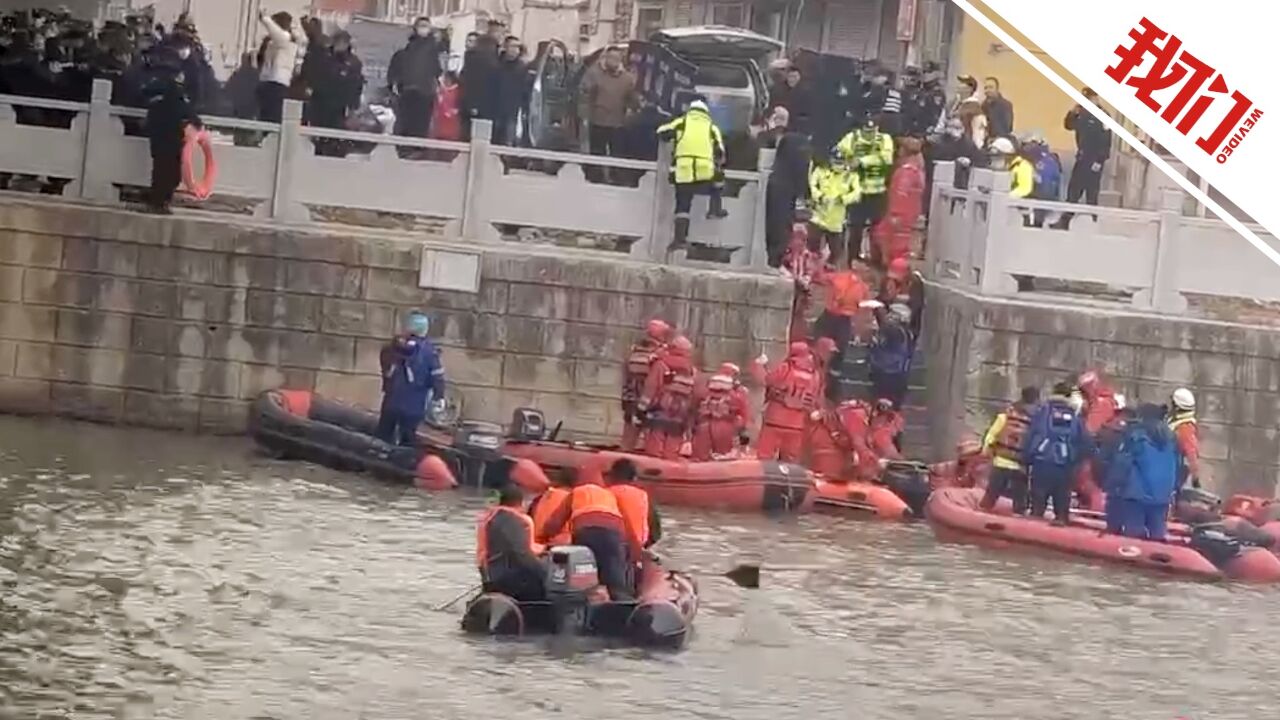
[374,310,444,446]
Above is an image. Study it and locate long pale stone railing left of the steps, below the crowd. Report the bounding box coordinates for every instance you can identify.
[0,81,772,268]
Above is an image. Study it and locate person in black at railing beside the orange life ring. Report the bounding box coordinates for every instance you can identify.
[142,41,201,215]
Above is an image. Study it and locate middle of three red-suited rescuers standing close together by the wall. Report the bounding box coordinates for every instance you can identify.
[639,336,698,460]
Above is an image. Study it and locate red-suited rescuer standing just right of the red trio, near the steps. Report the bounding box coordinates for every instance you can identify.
[753,342,818,462]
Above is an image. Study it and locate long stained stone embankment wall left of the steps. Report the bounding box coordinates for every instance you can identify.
[0,196,791,437]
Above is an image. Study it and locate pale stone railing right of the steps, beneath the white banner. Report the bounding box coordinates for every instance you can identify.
[925,163,1280,314]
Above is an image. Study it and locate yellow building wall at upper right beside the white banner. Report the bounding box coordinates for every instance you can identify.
[947,14,1075,152]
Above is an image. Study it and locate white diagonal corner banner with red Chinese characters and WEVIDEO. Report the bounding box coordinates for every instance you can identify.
[954,0,1280,265]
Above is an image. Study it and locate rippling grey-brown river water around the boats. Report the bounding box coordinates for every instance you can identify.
[0,418,1280,720]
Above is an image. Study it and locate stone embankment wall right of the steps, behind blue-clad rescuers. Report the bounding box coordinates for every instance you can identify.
[924,283,1280,496]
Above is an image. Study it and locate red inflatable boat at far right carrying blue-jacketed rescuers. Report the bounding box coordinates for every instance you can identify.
[925,488,1280,583]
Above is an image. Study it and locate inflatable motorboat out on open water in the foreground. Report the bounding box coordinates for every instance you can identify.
[462,546,698,650]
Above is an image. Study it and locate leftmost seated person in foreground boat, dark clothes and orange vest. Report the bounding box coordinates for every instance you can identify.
[476,486,545,602]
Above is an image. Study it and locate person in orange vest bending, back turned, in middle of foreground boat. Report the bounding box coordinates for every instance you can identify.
[544,473,635,602]
